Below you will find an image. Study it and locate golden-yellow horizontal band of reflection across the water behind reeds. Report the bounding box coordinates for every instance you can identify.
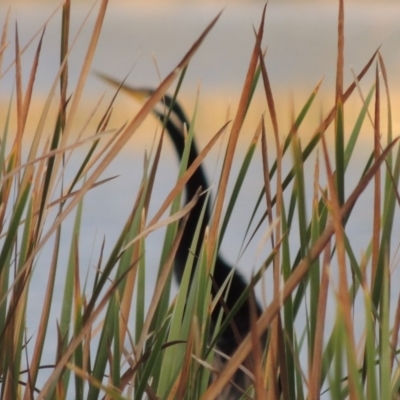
[0,90,400,155]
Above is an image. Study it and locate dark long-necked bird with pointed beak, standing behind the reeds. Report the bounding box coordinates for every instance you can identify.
[97,74,261,399]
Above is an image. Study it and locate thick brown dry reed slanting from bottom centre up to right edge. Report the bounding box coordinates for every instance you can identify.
[202,138,399,400]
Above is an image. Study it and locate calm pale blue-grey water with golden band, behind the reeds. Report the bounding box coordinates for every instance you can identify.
[0,1,400,396]
